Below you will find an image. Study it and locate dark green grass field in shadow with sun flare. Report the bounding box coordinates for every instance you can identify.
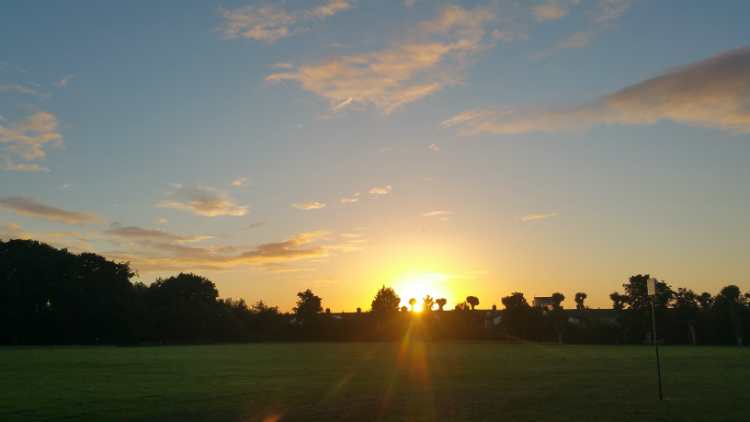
[0,341,750,422]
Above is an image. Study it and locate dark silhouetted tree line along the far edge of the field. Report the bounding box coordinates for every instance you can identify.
[0,240,750,345]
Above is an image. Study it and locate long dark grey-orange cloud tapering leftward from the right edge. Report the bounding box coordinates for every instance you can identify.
[441,47,750,134]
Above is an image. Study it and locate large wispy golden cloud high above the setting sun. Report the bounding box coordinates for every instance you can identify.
[266,6,494,114]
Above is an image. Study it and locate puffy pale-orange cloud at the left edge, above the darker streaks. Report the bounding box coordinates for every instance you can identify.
[0,111,63,171]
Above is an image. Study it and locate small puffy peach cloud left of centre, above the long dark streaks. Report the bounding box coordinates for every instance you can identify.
[156,184,250,217]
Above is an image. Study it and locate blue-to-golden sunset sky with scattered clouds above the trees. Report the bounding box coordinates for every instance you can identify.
[0,0,750,312]
